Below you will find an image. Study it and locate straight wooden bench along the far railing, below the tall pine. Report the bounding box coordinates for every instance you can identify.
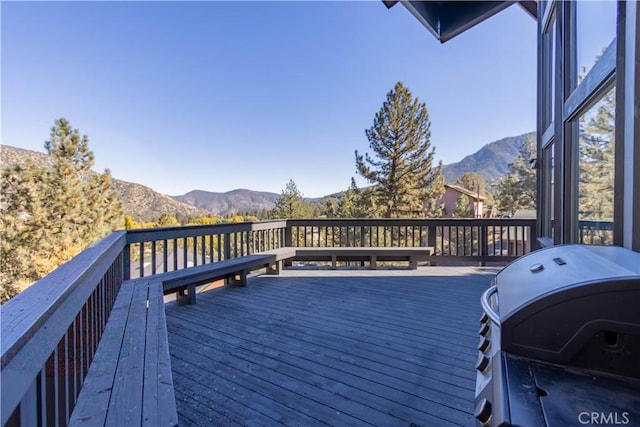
[294,247,433,270]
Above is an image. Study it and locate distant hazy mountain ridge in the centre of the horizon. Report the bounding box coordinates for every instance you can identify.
[172,189,280,215]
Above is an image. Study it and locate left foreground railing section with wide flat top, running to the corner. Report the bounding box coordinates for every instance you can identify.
[0,231,127,426]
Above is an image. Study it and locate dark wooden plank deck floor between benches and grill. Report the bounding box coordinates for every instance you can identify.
[166,267,497,427]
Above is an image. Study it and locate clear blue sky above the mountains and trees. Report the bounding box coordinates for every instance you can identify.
[1,1,536,197]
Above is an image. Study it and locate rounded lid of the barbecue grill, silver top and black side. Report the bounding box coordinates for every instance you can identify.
[495,245,640,378]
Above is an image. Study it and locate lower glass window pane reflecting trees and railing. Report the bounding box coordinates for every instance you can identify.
[578,87,616,245]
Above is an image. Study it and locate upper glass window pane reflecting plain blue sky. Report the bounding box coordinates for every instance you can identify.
[572,1,617,87]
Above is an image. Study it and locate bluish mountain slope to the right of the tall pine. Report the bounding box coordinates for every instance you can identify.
[442,132,536,186]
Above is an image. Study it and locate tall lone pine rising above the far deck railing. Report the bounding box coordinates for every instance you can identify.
[355,82,444,218]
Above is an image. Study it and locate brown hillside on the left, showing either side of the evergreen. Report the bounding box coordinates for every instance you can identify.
[0,145,209,222]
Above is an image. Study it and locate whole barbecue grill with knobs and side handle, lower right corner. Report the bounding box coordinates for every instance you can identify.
[475,245,640,426]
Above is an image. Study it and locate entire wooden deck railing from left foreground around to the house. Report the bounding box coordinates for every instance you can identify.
[0,219,536,426]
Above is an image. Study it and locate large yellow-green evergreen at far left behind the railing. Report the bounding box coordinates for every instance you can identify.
[0,118,123,302]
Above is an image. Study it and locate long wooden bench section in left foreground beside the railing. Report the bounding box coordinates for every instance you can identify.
[69,279,178,426]
